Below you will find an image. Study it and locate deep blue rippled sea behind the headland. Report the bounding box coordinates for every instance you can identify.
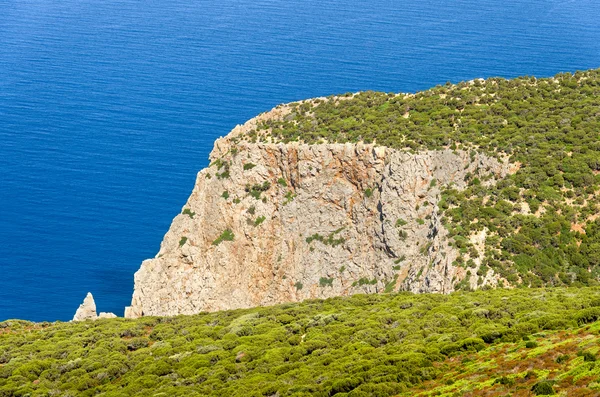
[0,0,600,321]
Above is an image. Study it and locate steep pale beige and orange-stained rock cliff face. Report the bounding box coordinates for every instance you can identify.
[125,106,510,317]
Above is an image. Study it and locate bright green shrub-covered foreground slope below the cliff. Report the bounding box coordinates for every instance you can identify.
[0,287,600,397]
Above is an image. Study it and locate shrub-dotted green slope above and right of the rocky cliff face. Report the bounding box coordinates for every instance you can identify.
[238,70,600,288]
